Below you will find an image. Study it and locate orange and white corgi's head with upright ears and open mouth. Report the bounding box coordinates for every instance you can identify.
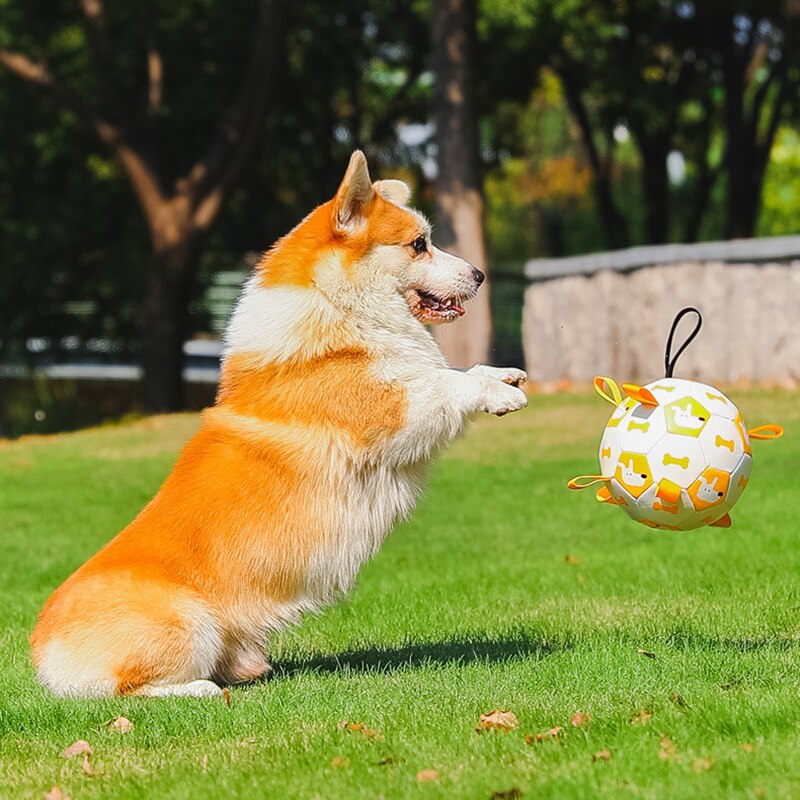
[261,151,484,325]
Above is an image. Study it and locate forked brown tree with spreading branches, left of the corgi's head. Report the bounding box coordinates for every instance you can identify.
[0,0,281,412]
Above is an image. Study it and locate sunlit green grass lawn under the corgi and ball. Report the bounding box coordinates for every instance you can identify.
[0,391,800,800]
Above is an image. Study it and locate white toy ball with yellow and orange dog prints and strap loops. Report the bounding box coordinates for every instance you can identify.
[567,308,783,531]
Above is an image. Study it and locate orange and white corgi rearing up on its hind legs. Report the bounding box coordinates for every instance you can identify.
[31,151,527,697]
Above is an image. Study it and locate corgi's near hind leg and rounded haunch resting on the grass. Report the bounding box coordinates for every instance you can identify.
[32,573,222,697]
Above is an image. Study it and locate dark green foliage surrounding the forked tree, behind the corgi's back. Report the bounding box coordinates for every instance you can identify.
[0,0,430,368]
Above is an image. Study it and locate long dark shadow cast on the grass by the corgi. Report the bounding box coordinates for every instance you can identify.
[271,633,572,678]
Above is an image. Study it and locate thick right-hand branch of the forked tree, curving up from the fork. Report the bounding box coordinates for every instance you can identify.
[185,0,280,205]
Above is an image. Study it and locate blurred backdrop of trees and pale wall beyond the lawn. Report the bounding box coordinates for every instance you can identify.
[0,0,800,436]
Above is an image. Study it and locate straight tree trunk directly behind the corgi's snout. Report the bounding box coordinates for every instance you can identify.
[432,0,492,367]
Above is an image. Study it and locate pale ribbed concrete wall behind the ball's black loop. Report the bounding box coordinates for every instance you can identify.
[523,237,800,389]
